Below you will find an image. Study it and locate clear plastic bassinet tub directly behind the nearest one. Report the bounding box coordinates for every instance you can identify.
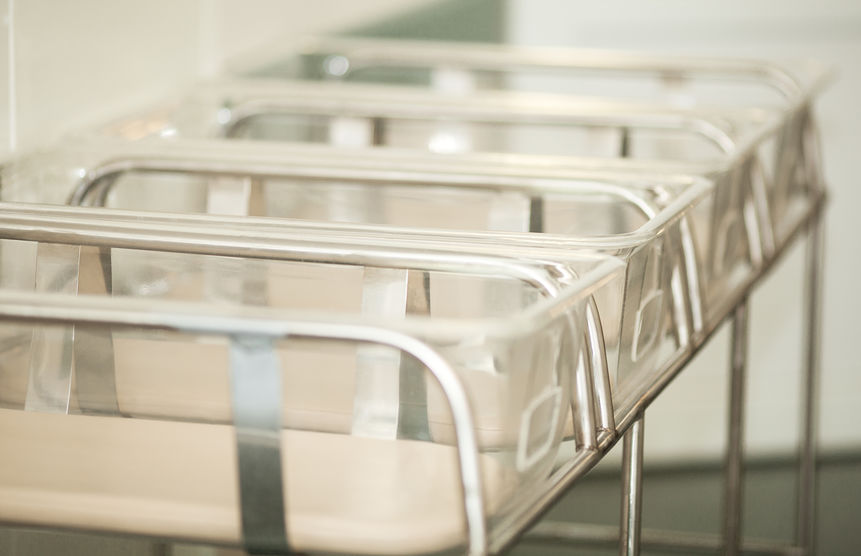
[2,141,740,431]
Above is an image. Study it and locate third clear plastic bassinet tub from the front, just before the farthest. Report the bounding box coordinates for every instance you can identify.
[80,80,776,318]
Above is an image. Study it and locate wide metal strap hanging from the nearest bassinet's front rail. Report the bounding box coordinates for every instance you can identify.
[230,336,289,554]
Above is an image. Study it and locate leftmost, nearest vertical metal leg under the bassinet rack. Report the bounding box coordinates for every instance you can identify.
[619,414,643,556]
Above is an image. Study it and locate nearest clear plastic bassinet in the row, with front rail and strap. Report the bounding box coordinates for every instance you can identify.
[0,204,623,554]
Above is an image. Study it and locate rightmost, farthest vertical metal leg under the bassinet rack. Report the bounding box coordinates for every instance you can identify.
[795,216,824,554]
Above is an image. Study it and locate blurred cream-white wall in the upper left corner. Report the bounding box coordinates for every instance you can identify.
[0,0,428,153]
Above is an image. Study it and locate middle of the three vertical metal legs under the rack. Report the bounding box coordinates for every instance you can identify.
[723,299,748,555]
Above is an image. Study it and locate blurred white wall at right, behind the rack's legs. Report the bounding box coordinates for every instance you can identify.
[508,0,861,460]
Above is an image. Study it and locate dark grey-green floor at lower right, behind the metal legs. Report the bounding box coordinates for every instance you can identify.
[512,454,861,556]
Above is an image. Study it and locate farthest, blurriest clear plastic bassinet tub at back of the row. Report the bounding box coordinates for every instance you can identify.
[252,32,833,244]
